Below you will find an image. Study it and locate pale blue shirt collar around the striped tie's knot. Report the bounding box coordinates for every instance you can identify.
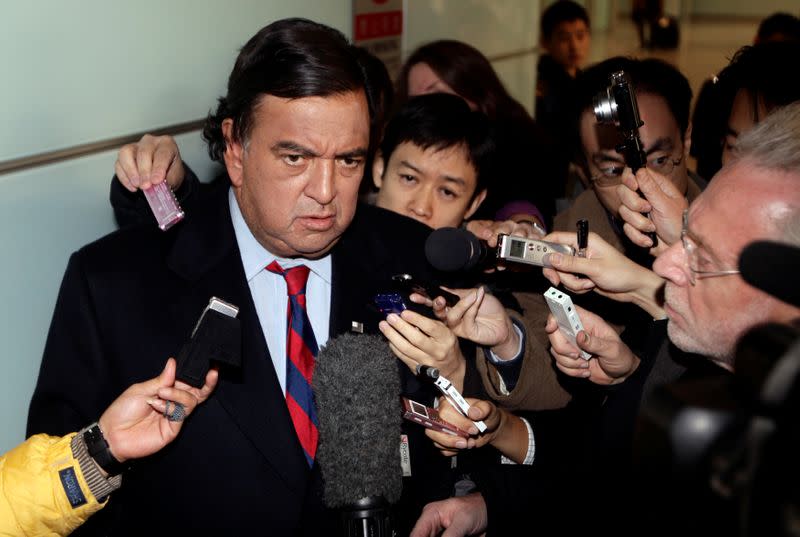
[228,188,332,284]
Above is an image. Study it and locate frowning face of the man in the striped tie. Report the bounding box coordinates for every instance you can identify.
[223,92,369,259]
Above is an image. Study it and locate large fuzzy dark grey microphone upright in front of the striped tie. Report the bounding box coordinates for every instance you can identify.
[313,333,403,537]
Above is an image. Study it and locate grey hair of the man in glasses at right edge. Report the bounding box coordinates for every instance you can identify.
[734,101,800,174]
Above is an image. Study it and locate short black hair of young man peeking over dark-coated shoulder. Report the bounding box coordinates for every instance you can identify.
[380,93,496,196]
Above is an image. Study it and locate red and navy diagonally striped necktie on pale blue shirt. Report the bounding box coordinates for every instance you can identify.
[267,261,319,466]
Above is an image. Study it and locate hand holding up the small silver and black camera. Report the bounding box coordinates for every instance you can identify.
[617,168,689,256]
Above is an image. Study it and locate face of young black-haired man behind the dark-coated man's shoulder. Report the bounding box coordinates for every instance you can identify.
[372,142,486,229]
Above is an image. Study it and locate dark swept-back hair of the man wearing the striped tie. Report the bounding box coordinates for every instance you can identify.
[203,18,376,160]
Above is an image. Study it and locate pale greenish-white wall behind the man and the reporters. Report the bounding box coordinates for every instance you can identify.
[0,0,539,453]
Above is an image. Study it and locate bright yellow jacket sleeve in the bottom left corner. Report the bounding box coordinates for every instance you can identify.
[0,433,107,536]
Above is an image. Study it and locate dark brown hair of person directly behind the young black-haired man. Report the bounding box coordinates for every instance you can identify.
[395,39,530,120]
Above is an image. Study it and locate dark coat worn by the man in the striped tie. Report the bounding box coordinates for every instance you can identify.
[28,178,468,536]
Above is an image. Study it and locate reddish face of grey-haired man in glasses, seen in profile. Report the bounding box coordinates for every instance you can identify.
[653,162,798,367]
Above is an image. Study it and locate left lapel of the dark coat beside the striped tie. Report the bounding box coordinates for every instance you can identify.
[168,184,309,491]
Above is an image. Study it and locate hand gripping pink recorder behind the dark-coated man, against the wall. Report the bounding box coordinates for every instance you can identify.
[114,134,186,192]
